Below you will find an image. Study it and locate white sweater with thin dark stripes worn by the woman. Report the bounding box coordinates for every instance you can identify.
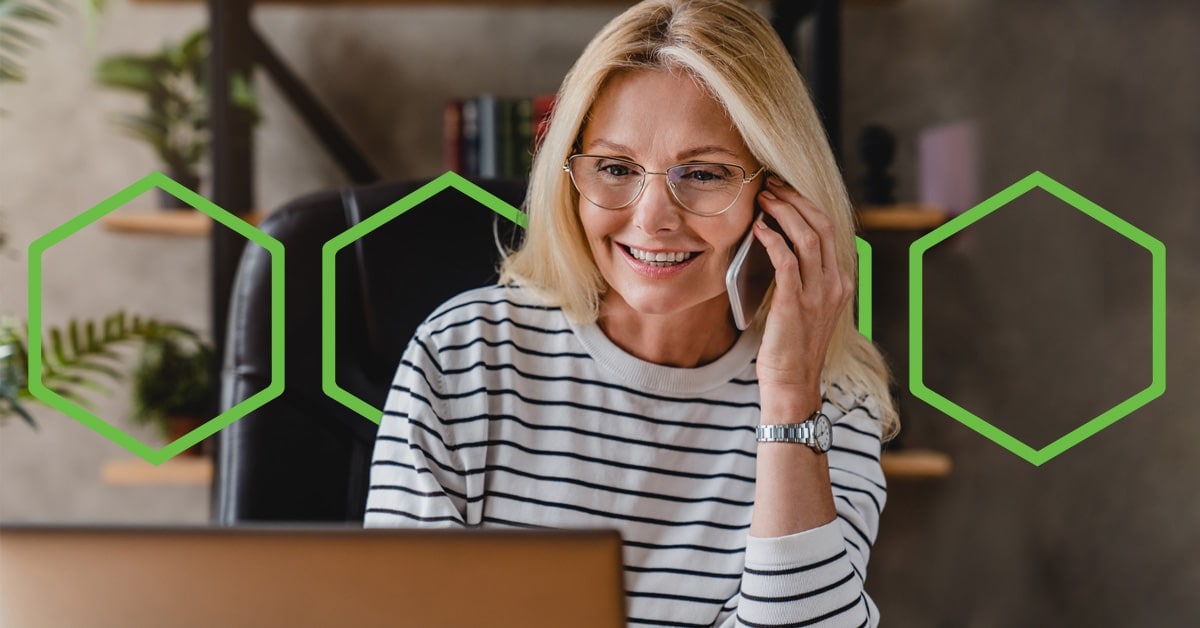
[366,287,886,627]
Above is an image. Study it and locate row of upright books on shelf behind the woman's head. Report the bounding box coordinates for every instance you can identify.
[443,94,554,179]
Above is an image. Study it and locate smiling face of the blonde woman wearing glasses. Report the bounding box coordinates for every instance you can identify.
[580,70,762,324]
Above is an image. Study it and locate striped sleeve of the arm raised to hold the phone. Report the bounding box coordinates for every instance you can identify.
[720,393,886,628]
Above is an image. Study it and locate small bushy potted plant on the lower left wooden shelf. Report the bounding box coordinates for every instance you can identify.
[132,324,217,454]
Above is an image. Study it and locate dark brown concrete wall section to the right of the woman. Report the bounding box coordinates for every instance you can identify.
[845,0,1200,628]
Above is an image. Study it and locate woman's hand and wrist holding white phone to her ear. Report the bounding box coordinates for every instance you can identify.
[754,175,854,400]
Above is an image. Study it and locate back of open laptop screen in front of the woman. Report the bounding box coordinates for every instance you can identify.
[0,526,625,628]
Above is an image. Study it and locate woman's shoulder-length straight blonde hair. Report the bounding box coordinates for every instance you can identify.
[502,0,899,436]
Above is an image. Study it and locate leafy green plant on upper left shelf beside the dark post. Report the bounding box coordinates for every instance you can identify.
[95,28,259,208]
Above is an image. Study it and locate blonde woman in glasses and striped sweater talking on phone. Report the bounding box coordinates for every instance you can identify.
[366,0,896,626]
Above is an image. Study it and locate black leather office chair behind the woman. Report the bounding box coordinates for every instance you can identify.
[214,180,524,525]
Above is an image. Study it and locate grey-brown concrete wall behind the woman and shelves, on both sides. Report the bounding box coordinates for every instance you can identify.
[0,0,1200,627]
